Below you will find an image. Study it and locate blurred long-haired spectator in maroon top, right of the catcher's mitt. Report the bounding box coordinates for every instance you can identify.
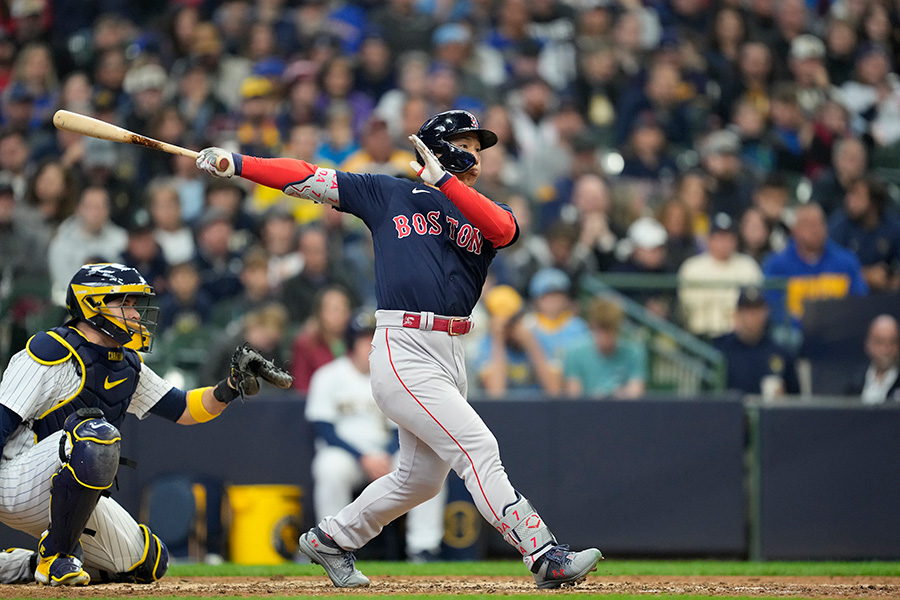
[288,285,351,393]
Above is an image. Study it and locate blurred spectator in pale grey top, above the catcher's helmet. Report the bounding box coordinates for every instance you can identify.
[48,186,128,299]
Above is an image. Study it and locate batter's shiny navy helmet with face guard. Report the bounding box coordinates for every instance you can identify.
[416,110,497,173]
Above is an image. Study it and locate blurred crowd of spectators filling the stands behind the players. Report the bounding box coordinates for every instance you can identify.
[0,0,900,404]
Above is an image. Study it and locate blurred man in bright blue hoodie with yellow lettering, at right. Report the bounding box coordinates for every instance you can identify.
[762,204,869,328]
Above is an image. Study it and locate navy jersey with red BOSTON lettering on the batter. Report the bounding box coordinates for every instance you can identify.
[337,172,519,317]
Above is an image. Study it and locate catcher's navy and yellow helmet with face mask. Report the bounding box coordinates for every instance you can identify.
[66,263,159,351]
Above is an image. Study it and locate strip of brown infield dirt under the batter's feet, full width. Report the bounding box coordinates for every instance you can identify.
[0,576,900,598]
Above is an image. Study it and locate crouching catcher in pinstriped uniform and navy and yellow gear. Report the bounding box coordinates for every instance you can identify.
[0,263,288,586]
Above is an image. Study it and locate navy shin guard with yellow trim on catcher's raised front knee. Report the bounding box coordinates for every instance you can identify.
[40,409,122,558]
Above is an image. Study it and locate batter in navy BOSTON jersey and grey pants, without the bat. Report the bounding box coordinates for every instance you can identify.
[197,110,602,588]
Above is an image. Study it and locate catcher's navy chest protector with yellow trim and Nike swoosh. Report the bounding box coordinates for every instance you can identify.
[27,327,141,441]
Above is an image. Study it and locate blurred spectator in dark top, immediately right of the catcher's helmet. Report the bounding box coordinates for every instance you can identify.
[156,262,214,338]
